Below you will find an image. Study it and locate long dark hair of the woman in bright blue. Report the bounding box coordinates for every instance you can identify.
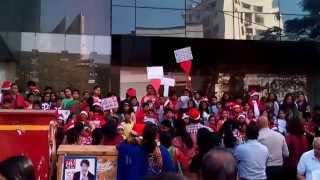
[141,124,158,154]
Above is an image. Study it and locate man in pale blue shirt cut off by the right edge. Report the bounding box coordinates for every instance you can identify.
[297,137,320,180]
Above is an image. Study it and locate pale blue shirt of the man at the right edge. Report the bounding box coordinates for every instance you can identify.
[297,150,320,180]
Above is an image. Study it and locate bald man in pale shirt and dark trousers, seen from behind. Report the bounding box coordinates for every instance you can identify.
[258,116,289,180]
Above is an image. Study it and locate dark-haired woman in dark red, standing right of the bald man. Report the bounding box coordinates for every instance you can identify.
[285,120,309,179]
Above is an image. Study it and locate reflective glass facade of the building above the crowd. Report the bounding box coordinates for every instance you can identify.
[0,0,320,100]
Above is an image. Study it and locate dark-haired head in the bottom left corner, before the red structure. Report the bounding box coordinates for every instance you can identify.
[0,156,35,180]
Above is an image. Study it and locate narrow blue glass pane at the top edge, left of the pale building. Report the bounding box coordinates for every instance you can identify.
[136,0,185,10]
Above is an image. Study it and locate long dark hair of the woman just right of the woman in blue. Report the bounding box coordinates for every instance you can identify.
[174,120,193,149]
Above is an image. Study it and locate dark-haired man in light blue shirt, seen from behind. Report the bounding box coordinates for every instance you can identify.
[234,123,268,180]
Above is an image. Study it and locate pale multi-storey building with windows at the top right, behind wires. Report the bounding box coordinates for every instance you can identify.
[187,0,283,39]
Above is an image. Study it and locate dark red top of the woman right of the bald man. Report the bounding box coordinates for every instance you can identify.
[286,134,309,169]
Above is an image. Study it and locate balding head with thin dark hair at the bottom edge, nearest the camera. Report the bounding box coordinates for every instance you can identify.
[201,149,237,180]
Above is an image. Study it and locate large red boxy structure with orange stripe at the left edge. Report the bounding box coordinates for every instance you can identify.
[0,110,57,179]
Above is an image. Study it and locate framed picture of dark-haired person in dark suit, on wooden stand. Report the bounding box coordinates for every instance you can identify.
[62,156,97,180]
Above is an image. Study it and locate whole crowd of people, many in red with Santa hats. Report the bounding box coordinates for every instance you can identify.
[0,81,320,180]
